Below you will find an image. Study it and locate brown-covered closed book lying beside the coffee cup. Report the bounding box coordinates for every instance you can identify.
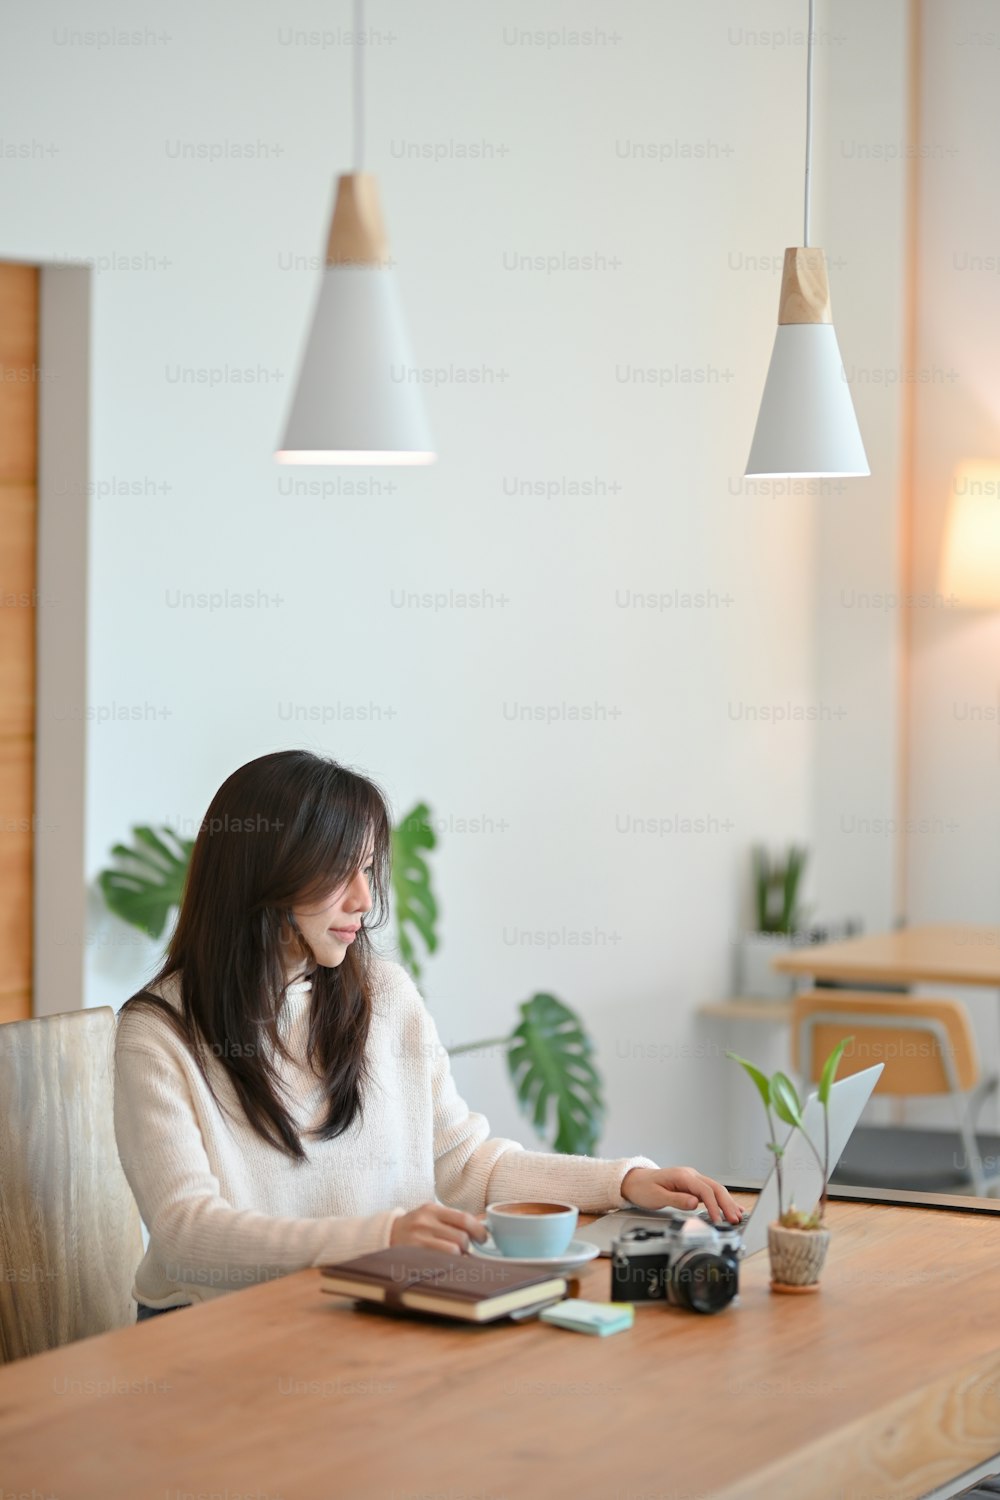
[319,1245,567,1323]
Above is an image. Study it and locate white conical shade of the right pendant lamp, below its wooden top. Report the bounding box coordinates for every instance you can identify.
[747,323,871,479]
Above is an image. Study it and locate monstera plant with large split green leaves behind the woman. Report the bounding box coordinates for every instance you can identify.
[97,803,604,1155]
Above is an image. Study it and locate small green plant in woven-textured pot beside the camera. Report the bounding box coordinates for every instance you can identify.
[726,1037,853,1292]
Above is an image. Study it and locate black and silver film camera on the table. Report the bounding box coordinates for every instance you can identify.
[612,1214,744,1313]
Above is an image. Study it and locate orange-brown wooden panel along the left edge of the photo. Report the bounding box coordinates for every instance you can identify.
[0,264,39,1022]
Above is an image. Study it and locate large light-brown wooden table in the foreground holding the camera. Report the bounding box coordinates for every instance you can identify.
[0,1203,1000,1500]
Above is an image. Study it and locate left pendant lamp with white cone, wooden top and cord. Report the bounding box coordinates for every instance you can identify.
[274,0,435,465]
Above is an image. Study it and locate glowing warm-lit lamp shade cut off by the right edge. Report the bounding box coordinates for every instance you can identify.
[940,462,1000,609]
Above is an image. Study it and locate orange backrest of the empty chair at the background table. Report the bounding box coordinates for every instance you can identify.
[792,990,979,1097]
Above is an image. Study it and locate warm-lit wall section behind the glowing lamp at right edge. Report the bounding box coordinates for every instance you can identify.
[909,0,1000,1104]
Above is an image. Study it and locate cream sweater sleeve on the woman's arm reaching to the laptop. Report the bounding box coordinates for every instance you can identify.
[414,989,657,1214]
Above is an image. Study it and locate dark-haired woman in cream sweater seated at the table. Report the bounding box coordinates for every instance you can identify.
[115,750,741,1319]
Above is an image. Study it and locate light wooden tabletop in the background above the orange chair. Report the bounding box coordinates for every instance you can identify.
[772,923,1000,989]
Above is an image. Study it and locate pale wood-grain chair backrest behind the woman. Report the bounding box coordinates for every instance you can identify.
[0,1007,142,1362]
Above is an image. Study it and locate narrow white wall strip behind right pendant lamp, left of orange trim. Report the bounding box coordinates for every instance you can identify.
[813,0,909,930]
